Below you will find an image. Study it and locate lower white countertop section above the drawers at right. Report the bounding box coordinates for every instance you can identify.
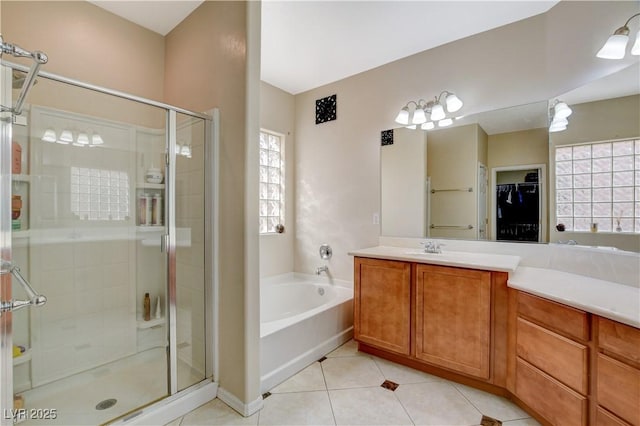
[508,266,640,328]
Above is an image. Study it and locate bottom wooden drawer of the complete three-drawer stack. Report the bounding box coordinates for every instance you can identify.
[515,358,588,426]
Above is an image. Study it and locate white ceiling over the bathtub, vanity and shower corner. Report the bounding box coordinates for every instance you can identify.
[91,0,558,94]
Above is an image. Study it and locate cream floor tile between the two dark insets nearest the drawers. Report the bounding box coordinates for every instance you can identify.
[395,382,482,426]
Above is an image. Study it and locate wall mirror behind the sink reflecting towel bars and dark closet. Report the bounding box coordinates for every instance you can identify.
[381,102,548,241]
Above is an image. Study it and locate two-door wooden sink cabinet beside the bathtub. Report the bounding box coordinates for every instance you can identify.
[354,257,507,390]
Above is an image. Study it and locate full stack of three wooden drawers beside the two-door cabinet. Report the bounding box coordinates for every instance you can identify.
[512,292,590,425]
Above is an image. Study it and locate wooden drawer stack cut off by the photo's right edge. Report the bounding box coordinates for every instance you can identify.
[595,317,640,426]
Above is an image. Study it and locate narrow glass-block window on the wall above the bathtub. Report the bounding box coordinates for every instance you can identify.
[260,131,284,234]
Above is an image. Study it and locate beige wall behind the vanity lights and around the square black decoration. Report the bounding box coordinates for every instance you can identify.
[295,2,635,279]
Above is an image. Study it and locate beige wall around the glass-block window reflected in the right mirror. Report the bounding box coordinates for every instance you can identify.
[549,95,640,251]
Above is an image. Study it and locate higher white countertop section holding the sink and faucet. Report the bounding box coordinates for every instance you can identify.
[349,246,520,272]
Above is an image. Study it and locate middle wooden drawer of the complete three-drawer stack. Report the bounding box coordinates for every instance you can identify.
[516,318,588,395]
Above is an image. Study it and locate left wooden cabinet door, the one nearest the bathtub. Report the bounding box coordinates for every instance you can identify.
[354,257,411,355]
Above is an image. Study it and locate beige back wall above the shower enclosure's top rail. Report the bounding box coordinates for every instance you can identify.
[1,0,164,100]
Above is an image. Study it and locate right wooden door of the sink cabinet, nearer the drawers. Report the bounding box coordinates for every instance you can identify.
[415,265,491,379]
